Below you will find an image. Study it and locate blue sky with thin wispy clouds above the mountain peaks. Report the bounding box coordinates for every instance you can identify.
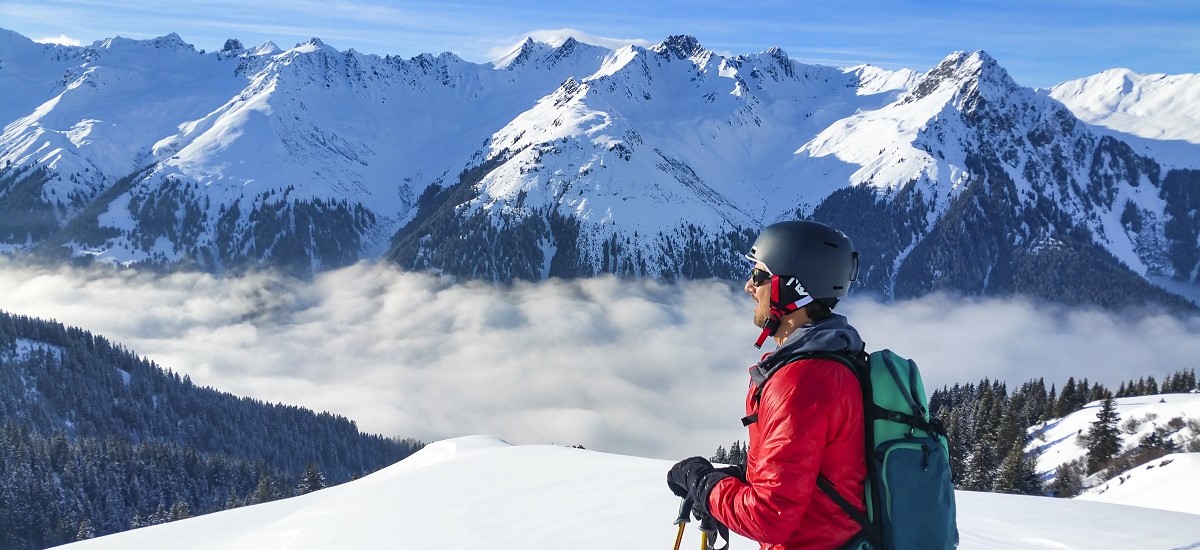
[0,0,1200,86]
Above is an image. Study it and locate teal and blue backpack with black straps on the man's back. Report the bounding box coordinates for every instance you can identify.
[743,349,959,550]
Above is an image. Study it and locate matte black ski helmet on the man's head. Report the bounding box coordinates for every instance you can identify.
[746,221,858,300]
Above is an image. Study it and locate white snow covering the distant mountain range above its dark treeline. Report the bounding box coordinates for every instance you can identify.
[0,31,1200,292]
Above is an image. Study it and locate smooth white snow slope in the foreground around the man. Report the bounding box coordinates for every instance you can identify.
[62,436,1200,550]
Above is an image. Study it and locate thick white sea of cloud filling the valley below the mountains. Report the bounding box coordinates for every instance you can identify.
[0,262,1200,459]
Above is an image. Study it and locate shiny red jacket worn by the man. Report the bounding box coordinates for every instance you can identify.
[708,359,866,550]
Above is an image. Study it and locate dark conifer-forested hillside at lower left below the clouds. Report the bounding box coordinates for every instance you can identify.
[0,311,420,550]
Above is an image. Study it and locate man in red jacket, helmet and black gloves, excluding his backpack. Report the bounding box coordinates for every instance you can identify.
[667,221,866,550]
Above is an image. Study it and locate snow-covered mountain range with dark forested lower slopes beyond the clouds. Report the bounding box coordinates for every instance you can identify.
[0,31,1200,306]
